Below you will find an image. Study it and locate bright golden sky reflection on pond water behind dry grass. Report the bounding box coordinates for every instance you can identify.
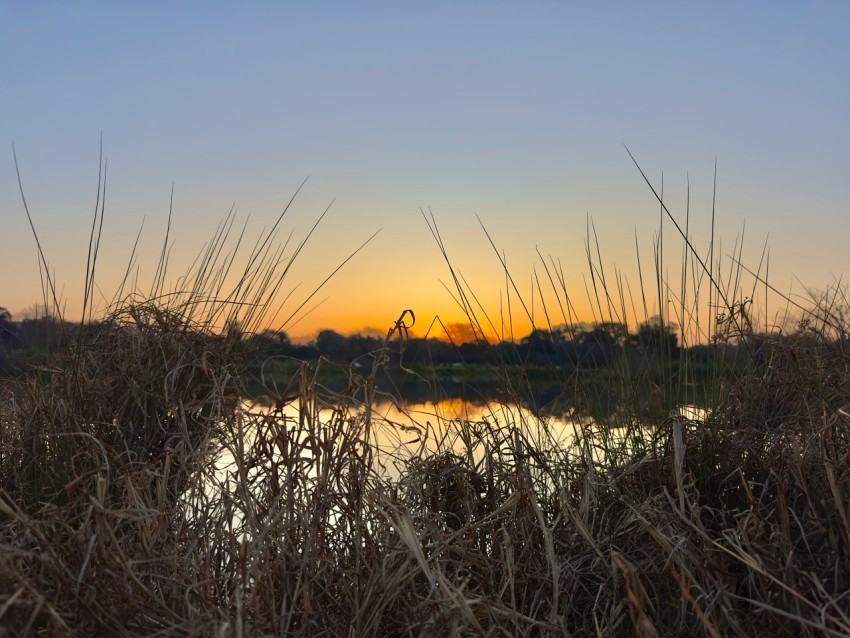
[199,399,706,538]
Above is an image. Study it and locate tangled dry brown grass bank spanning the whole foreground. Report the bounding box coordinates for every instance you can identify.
[0,168,850,637]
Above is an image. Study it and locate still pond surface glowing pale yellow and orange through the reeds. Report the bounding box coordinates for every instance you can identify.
[203,399,705,529]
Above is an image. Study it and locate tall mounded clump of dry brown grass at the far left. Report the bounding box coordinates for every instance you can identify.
[0,306,234,635]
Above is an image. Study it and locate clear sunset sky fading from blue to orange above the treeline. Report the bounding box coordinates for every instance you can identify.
[0,2,850,339]
